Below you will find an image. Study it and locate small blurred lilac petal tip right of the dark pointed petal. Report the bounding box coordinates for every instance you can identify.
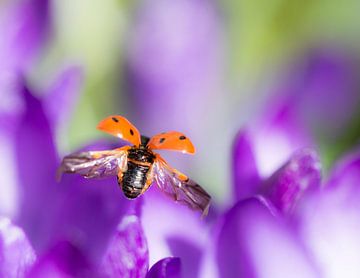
[44,66,83,132]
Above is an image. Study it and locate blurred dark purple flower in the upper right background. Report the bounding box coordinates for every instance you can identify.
[264,46,360,142]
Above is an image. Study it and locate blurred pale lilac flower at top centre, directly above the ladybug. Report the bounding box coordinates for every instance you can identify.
[128,0,220,133]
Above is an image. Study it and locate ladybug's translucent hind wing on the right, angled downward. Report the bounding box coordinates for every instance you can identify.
[154,156,211,216]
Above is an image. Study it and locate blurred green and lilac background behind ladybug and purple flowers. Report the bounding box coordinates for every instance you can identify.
[0,0,360,276]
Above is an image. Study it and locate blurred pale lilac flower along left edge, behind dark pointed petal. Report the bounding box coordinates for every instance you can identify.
[0,0,50,215]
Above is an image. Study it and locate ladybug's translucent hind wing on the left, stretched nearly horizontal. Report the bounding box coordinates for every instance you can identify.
[58,148,127,178]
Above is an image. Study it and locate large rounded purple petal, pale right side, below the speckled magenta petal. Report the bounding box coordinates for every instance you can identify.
[216,198,317,278]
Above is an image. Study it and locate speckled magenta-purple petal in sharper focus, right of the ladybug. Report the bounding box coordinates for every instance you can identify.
[260,149,321,214]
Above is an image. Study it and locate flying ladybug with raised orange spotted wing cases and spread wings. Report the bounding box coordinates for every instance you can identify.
[59,115,211,215]
